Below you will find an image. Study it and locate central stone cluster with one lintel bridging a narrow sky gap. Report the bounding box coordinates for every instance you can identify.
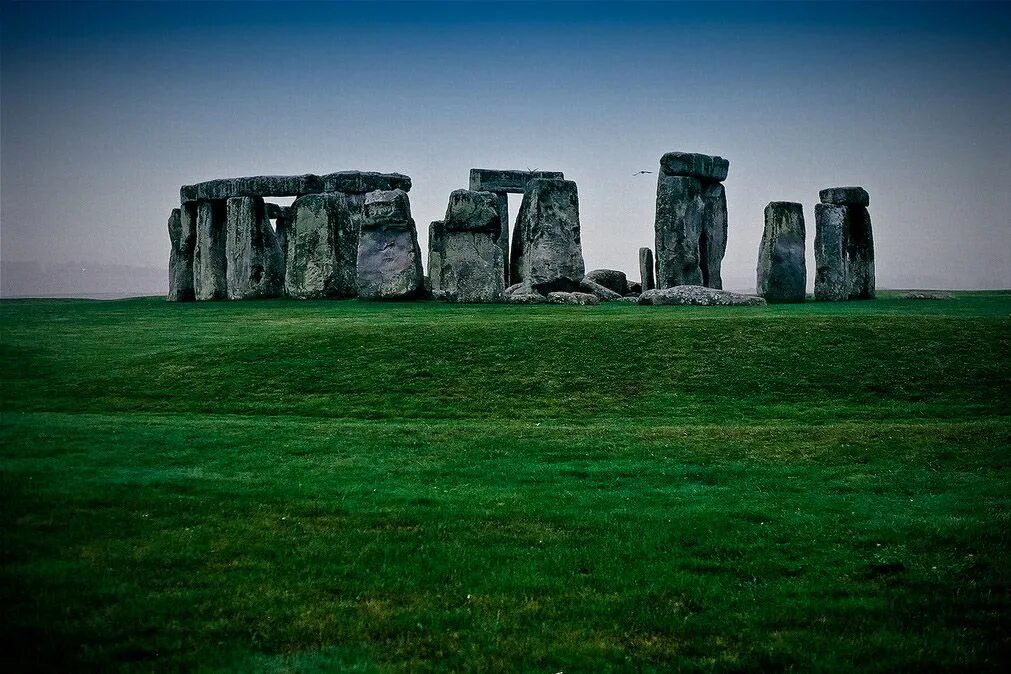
[429,169,585,302]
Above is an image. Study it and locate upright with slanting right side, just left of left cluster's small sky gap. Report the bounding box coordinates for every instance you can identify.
[224,197,284,299]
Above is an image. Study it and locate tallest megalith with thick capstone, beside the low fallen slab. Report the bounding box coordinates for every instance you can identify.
[654,153,730,289]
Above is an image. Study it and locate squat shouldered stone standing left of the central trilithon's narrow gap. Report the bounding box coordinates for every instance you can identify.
[429,190,506,302]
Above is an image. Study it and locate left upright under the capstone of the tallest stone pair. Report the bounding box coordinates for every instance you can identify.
[655,175,705,288]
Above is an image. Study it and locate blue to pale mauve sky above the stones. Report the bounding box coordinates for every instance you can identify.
[0,2,1011,289]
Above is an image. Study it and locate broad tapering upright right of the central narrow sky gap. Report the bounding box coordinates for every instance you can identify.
[510,178,585,293]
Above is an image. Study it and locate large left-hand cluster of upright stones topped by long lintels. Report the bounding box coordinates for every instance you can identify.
[169,171,423,300]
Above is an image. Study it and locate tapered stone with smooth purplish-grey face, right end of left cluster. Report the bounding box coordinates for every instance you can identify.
[358,190,423,300]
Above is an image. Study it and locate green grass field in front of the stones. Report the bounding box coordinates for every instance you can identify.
[0,292,1011,673]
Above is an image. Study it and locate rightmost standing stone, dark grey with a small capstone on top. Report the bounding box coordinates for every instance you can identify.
[815,187,875,301]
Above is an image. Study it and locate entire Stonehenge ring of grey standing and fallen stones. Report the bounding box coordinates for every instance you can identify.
[167,152,875,306]
